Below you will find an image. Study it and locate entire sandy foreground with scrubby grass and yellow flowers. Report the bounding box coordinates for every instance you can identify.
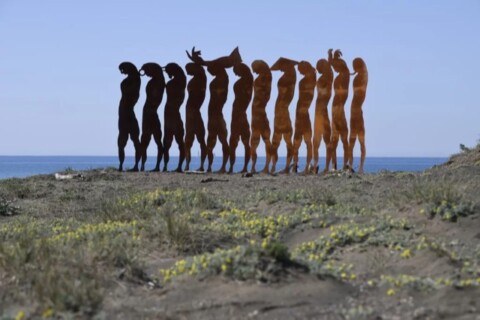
[0,147,480,319]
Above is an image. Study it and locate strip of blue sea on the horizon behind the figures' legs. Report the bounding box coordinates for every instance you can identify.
[0,156,448,179]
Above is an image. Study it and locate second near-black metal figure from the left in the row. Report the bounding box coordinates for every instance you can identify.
[135,62,165,171]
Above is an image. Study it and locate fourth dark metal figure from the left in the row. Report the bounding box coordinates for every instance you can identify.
[185,63,207,171]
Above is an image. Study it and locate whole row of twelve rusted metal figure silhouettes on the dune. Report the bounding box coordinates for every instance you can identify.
[118,47,368,174]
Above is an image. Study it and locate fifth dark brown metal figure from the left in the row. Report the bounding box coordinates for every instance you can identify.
[207,63,229,173]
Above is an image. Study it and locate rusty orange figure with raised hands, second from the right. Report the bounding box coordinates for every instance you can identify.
[327,49,350,170]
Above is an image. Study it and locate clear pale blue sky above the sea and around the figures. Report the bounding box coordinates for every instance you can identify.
[0,0,480,156]
